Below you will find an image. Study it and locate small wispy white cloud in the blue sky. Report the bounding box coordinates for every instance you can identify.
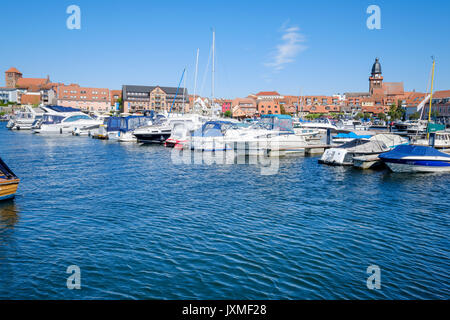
[265,26,308,71]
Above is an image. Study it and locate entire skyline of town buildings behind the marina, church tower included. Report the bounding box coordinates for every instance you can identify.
[0,58,450,118]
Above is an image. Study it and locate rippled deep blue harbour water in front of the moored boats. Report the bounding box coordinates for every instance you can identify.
[0,124,450,299]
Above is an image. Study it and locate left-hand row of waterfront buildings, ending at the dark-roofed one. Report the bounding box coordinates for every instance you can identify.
[0,67,189,113]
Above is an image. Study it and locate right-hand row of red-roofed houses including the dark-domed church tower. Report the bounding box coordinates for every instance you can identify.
[212,58,450,118]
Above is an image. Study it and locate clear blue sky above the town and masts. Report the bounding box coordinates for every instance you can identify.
[0,0,450,97]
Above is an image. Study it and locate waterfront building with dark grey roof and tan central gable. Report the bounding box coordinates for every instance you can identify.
[122,85,189,113]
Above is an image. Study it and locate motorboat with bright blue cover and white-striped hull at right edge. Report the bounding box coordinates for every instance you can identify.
[379,145,450,172]
